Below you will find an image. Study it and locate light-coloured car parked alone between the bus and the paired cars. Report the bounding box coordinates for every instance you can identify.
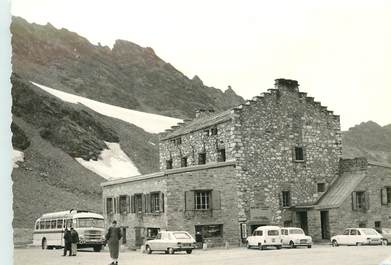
[145,231,195,254]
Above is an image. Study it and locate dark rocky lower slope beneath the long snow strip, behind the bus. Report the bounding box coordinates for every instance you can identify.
[11,74,158,228]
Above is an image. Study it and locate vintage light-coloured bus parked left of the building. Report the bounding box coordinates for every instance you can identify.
[33,209,105,252]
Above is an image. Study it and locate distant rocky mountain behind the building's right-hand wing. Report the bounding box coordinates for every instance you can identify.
[342,121,391,164]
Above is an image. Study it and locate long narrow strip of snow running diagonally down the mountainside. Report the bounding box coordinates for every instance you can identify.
[31,82,182,133]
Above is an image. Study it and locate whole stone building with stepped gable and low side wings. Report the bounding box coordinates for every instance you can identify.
[102,79,391,246]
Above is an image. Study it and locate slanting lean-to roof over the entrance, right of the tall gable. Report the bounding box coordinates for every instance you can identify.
[315,171,366,208]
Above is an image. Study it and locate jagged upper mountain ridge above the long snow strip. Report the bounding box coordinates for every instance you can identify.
[11,17,243,118]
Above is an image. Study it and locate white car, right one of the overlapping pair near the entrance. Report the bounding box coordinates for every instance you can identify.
[281,227,312,248]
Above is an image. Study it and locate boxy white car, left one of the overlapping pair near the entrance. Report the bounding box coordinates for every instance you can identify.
[247,226,282,250]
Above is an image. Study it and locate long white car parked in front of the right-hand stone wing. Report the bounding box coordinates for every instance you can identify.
[331,228,383,247]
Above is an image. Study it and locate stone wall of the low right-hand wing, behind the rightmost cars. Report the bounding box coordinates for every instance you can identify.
[330,164,391,235]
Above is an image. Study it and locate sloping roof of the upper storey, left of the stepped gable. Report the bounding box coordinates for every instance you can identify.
[162,109,232,140]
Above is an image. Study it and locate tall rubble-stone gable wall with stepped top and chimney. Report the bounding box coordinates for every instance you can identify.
[232,80,342,225]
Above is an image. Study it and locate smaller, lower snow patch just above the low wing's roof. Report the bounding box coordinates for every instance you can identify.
[76,142,140,180]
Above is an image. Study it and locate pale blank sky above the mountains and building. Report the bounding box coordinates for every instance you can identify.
[11,0,391,130]
